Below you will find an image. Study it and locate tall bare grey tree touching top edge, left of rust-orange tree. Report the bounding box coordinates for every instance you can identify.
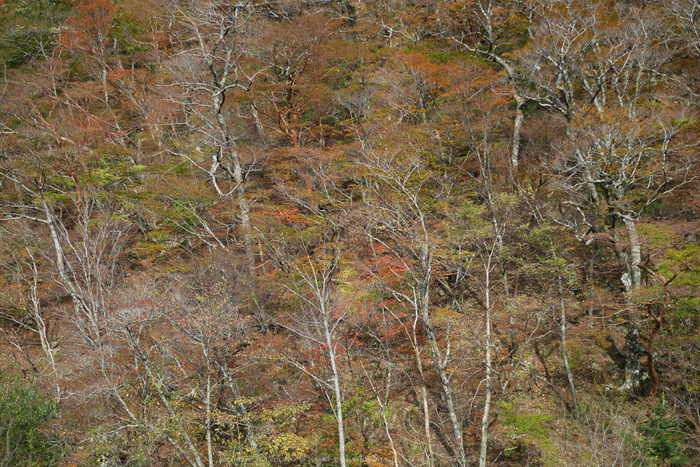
[163,0,265,324]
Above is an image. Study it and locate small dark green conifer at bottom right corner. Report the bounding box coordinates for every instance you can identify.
[636,404,690,467]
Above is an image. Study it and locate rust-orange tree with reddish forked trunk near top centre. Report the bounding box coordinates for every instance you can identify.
[250,11,353,148]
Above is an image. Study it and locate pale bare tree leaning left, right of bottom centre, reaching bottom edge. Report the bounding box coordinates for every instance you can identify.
[363,141,466,465]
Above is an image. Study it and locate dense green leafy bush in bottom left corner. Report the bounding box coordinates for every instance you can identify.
[0,375,62,467]
